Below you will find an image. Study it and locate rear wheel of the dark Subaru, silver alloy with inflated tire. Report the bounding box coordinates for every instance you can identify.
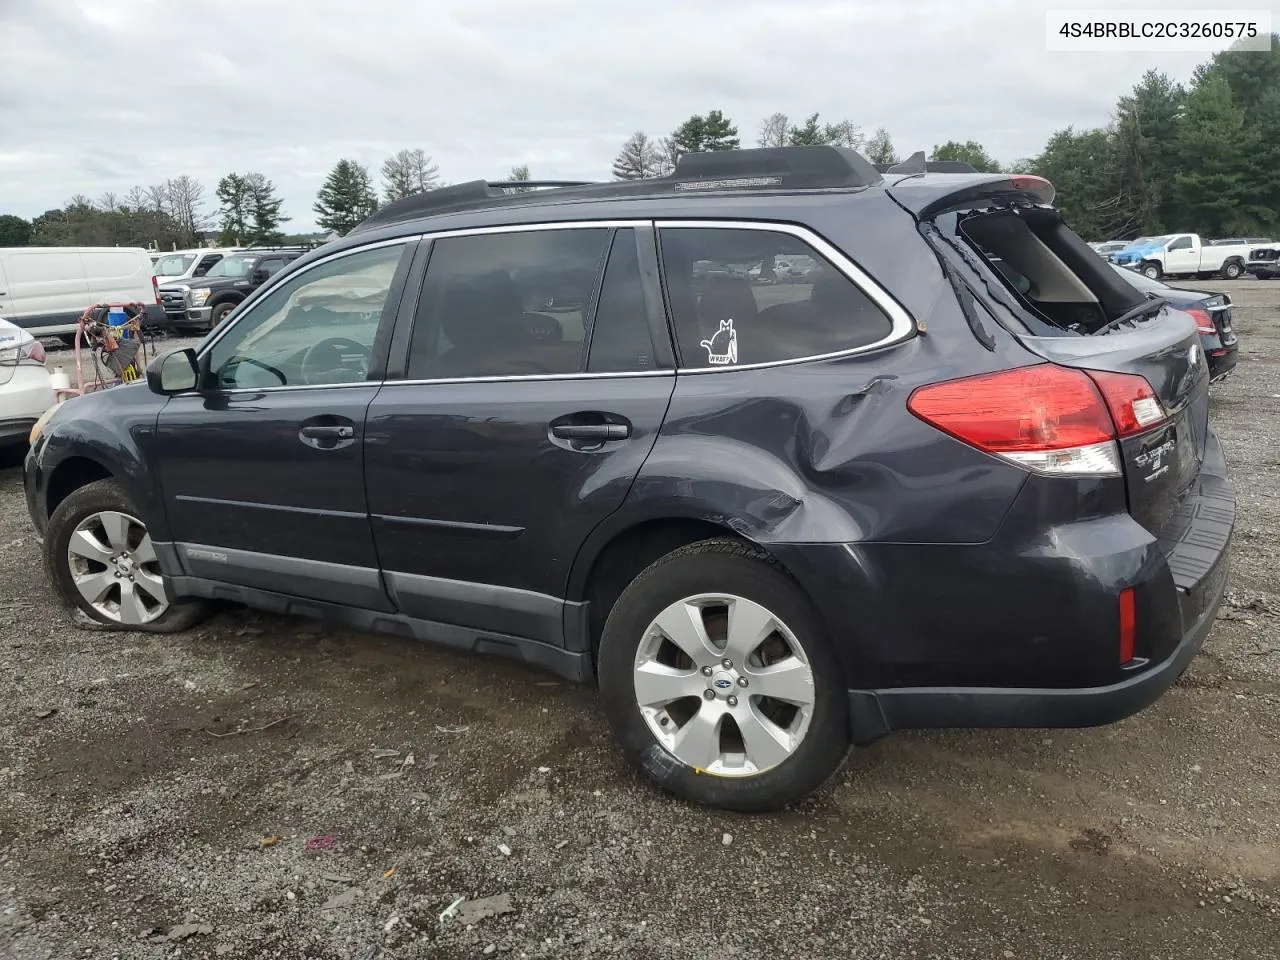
[598,540,850,812]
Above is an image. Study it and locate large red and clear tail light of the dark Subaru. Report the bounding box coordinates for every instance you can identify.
[906,364,1165,476]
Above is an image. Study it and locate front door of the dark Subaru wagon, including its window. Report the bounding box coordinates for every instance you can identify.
[152,243,413,609]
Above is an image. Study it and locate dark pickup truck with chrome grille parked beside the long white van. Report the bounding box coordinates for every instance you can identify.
[156,247,311,332]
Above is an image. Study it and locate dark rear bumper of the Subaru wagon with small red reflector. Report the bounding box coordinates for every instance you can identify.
[769,434,1235,744]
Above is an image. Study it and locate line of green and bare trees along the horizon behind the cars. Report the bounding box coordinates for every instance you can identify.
[0,35,1280,248]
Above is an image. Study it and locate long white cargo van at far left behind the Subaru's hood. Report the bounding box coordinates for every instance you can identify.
[0,247,164,337]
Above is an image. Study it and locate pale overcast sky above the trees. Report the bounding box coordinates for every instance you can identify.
[0,0,1274,230]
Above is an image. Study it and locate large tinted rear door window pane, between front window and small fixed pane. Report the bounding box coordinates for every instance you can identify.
[407,228,609,380]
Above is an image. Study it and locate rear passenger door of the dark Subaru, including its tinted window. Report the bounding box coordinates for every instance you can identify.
[365,223,675,645]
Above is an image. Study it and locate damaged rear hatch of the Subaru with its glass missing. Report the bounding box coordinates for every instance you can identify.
[890,174,1210,536]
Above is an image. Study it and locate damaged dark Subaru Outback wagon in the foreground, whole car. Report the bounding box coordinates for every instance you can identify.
[26,147,1235,810]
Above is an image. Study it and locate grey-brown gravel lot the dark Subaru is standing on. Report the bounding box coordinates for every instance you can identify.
[0,280,1280,960]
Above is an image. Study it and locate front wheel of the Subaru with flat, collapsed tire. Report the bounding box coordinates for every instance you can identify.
[44,480,209,634]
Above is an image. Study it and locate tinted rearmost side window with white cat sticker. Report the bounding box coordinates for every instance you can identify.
[659,227,892,369]
